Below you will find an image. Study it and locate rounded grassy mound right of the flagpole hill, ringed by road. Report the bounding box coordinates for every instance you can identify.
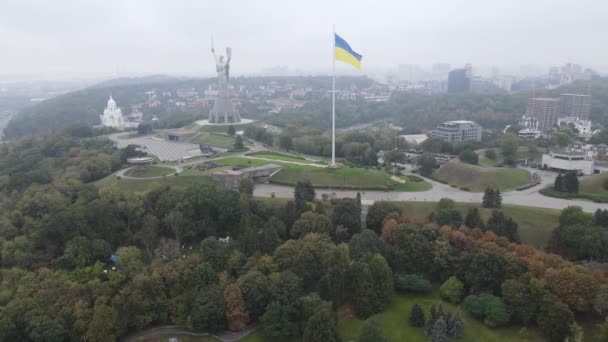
[433,160,530,192]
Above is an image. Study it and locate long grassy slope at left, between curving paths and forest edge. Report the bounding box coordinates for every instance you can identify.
[95,172,213,192]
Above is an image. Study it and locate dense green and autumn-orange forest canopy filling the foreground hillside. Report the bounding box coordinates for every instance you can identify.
[0,126,608,342]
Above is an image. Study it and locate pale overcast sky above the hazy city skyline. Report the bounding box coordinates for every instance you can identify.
[0,0,608,75]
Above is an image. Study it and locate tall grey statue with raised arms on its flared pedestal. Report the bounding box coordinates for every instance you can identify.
[209,41,241,124]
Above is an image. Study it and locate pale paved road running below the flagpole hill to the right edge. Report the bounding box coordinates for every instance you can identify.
[254,172,608,212]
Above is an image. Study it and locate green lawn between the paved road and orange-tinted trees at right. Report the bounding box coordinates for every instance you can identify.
[394,202,561,248]
